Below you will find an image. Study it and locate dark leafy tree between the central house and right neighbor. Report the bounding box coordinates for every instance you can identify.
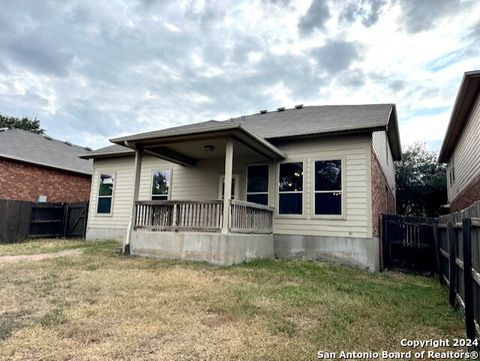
[395,143,447,217]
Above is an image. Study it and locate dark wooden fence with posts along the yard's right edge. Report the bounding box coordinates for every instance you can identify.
[435,202,480,339]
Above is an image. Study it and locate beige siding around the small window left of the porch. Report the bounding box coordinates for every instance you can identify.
[88,157,134,229]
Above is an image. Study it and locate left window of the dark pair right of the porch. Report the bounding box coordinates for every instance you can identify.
[278,162,303,215]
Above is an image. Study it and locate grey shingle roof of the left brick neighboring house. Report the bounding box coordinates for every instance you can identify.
[0,129,92,175]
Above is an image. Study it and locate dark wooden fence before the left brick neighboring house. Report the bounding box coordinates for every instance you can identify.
[0,200,88,243]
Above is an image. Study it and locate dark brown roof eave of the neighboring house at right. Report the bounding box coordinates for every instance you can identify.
[438,70,480,163]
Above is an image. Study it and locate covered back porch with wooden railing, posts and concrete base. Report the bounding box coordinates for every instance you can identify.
[113,124,285,264]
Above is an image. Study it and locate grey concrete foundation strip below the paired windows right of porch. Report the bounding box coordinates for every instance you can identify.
[274,234,380,272]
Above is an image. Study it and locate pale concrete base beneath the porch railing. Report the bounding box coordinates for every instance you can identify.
[130,231,274,266]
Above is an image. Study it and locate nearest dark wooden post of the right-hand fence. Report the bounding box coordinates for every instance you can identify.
[463,218,476,340]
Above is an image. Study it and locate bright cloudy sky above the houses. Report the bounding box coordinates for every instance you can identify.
[0,0,480,151]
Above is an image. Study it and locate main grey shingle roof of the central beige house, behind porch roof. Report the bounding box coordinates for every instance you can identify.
[92,104,401,159]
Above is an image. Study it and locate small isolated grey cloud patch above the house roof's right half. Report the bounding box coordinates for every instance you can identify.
[310,40,360,74]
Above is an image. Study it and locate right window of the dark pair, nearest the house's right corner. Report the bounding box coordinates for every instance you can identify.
[314,159,342,215]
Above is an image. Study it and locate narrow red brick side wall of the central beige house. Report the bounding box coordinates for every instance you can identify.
[372,148,396,237]
